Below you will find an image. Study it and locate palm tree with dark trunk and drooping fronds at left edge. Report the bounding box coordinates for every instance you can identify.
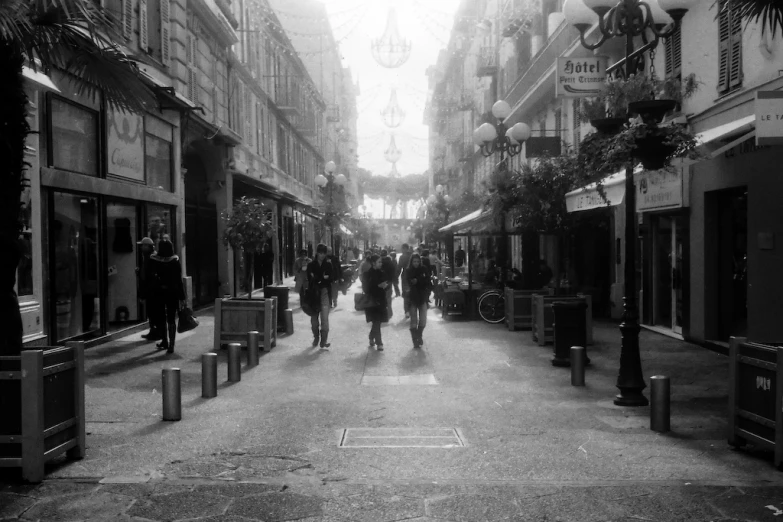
[0,0,156,355]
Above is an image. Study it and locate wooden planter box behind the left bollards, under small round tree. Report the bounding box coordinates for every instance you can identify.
[214,297,277,352]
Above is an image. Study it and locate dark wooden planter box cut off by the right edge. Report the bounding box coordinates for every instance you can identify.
[728,337,783,468]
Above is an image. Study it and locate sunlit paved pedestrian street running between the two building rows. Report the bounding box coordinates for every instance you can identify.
[0,284,783,522]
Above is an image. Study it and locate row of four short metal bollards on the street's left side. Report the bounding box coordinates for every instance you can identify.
[161,330,266,421]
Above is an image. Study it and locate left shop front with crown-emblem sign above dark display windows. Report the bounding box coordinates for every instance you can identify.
[38,76,182,344]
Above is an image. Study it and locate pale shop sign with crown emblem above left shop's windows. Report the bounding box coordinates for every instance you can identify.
[106,110,144,182]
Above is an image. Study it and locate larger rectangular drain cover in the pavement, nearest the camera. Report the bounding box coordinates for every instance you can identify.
[340,428,466,448]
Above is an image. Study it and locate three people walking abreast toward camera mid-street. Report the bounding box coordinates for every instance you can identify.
[295,244,432,351]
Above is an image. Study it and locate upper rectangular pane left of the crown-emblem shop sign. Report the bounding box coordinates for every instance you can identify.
[51,98,98,176]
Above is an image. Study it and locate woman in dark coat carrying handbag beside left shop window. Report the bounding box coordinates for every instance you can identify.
[150,239,185,353]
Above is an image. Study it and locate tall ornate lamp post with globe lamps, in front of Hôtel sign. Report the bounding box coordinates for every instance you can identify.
[563,0,698,406]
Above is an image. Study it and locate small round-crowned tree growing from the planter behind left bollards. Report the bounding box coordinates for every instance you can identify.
[221,197,273,299]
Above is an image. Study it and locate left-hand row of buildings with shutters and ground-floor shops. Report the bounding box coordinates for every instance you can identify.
[17,0,355,345]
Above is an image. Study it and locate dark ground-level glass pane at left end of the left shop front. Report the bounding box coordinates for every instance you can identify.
[50,192,101,341]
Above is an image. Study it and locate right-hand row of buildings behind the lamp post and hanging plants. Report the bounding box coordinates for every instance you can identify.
[430,0,783,347]
